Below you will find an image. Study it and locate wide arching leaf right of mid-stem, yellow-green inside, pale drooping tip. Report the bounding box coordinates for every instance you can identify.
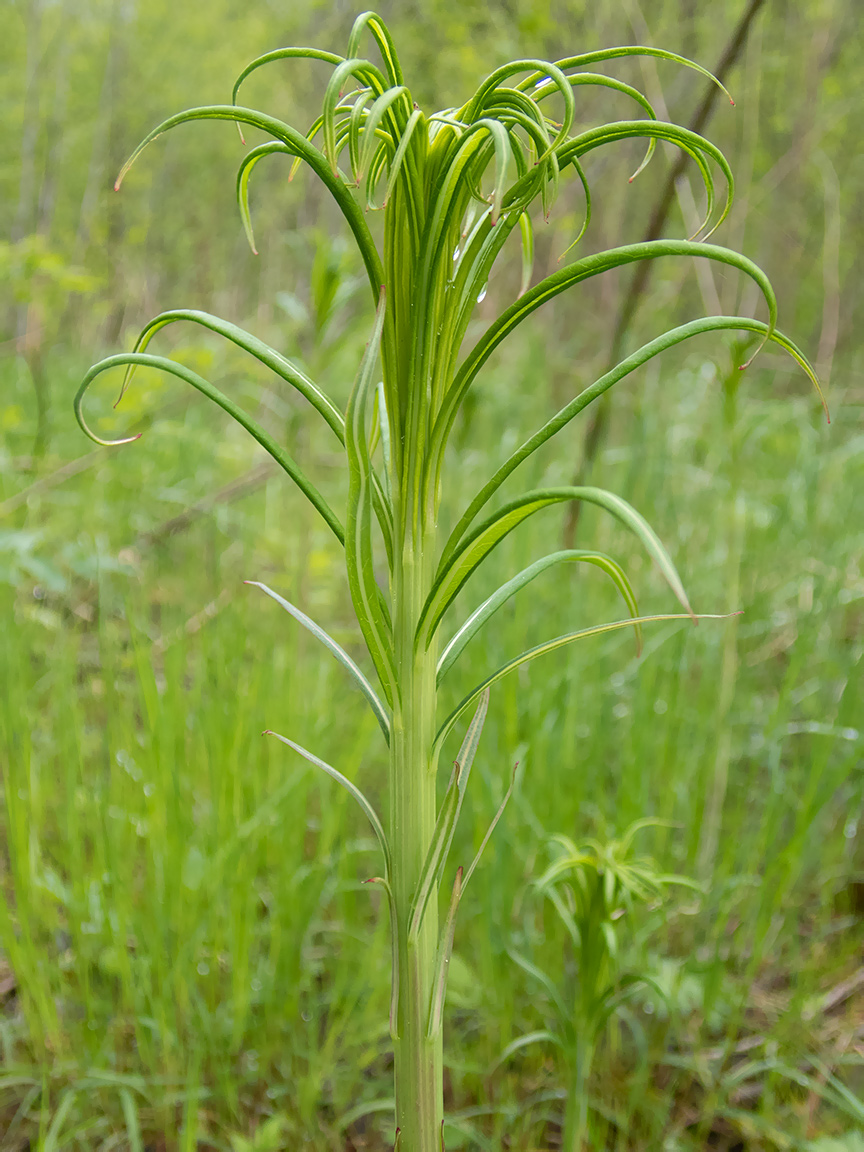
[417,487,691,647]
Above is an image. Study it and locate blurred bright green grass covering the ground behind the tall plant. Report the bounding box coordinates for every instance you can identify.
[0,301,864,1152]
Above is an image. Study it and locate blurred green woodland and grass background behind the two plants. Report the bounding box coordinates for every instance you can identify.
[0,0,864,1152]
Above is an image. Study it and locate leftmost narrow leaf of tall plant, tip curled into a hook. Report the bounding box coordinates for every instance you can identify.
[74,353,344,544]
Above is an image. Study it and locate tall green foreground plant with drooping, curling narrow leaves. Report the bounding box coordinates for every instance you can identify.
[75,13,814,1152]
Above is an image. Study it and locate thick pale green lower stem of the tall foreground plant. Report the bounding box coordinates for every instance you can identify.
[389,540,444,1152]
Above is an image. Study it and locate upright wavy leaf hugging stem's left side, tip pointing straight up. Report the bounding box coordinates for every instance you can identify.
[346,289,397,706]
